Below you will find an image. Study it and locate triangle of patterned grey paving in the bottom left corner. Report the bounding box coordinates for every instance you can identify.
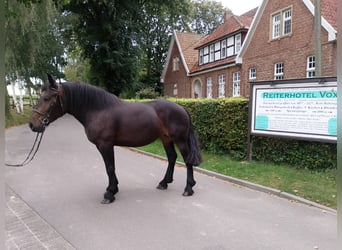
[5,185,75,250]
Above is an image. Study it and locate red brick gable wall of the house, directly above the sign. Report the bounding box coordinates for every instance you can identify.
[242,0,336,92]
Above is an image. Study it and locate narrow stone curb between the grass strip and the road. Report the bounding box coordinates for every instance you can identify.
[129,147,337,214]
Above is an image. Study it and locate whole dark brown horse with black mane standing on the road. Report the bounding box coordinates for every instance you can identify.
[30,75,201,204]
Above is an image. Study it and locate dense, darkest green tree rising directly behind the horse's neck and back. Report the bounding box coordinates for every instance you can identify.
[64,0,139,94]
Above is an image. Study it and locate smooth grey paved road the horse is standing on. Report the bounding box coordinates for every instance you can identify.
[5,116,337,250]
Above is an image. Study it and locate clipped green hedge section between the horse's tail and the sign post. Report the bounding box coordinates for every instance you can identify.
[176,98,248,159]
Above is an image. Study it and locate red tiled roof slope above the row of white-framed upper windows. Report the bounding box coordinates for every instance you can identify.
[198,8,258,47]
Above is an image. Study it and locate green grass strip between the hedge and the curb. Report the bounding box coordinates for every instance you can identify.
[139,141,337,208]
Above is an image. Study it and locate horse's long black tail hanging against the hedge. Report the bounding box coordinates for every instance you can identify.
[185,109,202,166]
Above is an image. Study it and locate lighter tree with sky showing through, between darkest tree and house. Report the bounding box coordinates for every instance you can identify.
[136,1,189,93]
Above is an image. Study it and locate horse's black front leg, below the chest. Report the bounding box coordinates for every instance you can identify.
[97,145,119,204]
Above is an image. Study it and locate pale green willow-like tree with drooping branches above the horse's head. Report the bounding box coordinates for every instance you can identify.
[5,0,65,109]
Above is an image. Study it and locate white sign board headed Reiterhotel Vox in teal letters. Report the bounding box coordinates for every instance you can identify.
[251,81,337,141]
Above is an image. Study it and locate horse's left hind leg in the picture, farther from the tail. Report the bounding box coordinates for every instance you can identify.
[157,142,177,189]
